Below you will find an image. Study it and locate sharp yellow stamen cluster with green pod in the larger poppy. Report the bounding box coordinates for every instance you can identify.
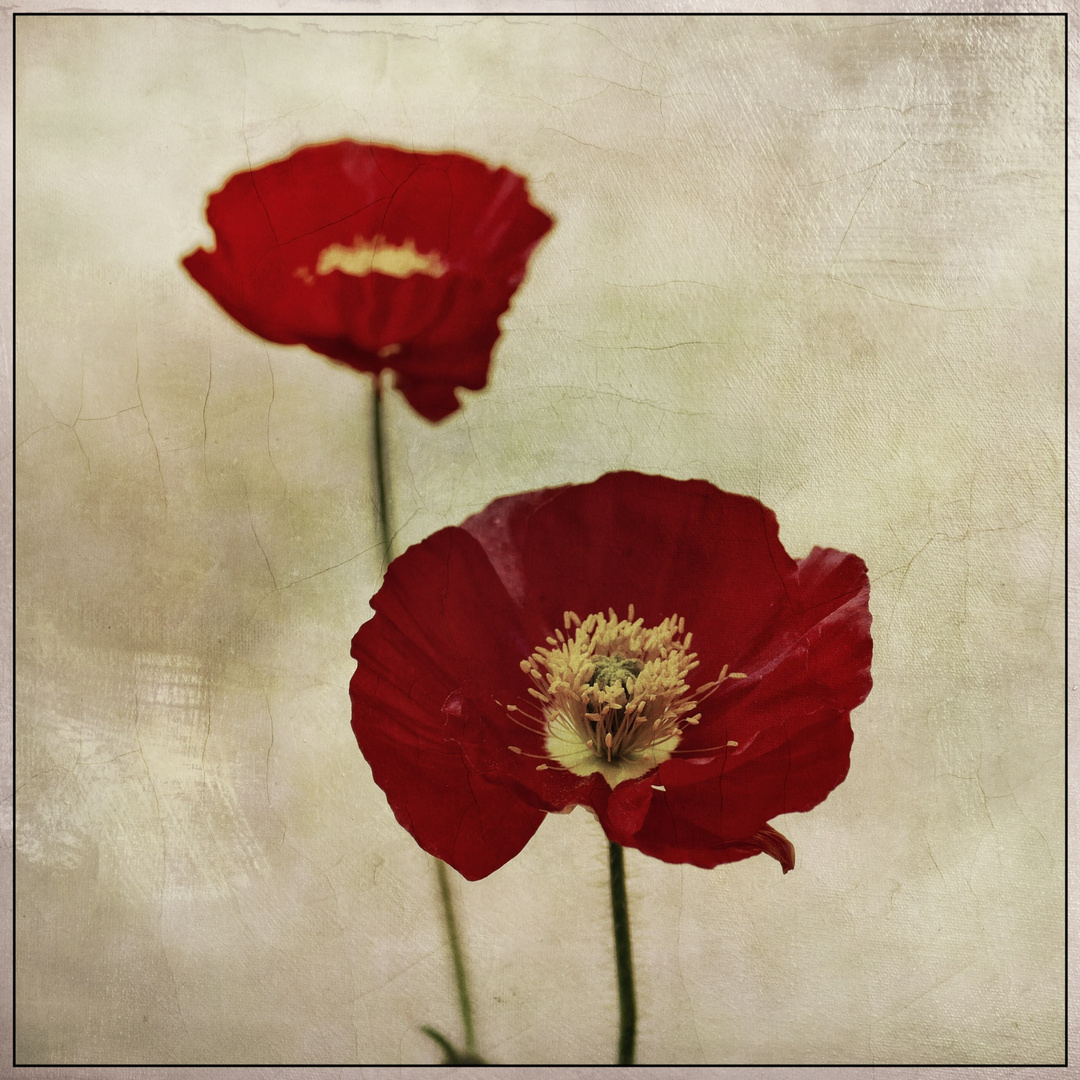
[512,605,745,787]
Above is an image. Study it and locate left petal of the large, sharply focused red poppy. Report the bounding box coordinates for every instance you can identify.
[350,529,543,879]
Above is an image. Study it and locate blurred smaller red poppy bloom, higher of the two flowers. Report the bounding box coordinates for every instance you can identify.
[184,140,552,420]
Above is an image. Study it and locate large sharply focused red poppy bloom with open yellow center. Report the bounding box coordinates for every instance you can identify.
[351,473,872,879]
